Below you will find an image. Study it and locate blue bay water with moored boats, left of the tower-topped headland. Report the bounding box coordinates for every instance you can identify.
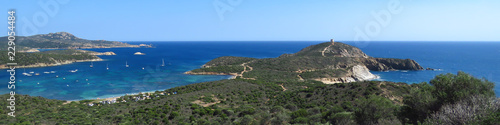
[0,42,320,100]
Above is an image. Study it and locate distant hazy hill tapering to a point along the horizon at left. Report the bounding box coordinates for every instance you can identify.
[0,32,139,50]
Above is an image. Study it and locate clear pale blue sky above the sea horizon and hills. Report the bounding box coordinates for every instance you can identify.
[0,0,500,41]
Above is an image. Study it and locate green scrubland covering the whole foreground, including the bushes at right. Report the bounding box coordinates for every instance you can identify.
[0,72,500,124]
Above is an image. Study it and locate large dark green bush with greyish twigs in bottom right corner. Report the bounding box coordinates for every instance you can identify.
[399,71,495,124]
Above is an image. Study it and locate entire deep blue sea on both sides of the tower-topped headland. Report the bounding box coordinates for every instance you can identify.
[0,41,500,100]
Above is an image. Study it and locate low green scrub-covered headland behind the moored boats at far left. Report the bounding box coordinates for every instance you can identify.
[0,50,100,66]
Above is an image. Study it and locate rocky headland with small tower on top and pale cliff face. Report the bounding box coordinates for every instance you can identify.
[185,40,424,84]
